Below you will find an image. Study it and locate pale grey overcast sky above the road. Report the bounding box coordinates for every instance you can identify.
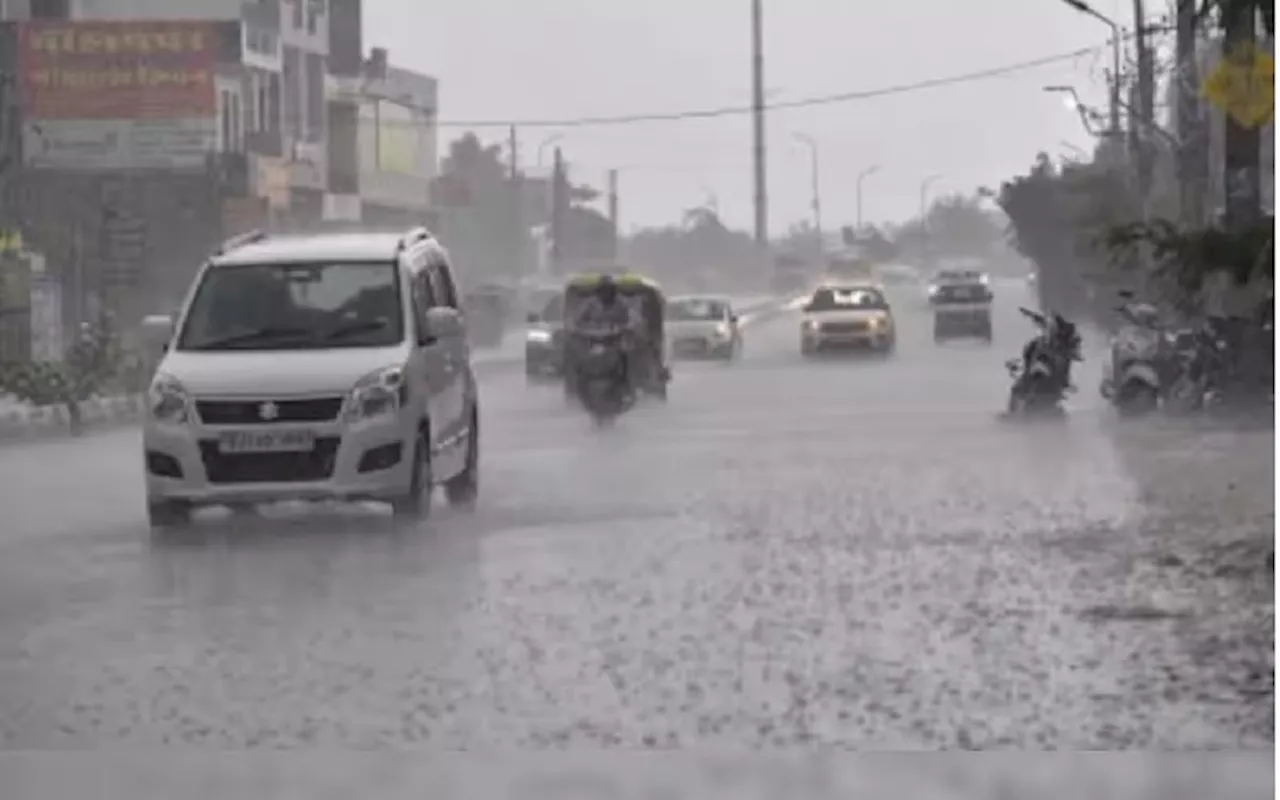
[365,0,1126,232]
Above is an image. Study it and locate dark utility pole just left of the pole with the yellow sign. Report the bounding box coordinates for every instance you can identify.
[1174,0,1208,228]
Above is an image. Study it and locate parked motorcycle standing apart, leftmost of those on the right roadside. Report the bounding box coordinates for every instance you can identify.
[1005,308,1080,417]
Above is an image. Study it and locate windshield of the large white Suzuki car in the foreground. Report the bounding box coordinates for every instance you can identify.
[178,261,404,351]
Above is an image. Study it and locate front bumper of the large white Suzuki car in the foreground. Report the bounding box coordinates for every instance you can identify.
[142,415,416,506]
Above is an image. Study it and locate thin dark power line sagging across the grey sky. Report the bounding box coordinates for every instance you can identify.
[401,36,1130,128]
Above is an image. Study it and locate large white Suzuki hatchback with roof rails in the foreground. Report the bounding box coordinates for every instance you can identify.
[143,228,480,527]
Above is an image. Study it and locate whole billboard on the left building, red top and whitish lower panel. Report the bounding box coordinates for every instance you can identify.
[19,20,218,169]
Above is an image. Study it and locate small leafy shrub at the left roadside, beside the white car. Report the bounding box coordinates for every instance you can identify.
[0,317,123,435]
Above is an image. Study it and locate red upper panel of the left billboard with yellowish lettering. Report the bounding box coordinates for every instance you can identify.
[18,20,218,119]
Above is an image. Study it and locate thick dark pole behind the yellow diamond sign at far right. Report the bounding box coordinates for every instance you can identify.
[1222,4,1262,230]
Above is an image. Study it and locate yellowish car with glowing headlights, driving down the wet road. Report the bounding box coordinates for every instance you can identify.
[800,283,897,356]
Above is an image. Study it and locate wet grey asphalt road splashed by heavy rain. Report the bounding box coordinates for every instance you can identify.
[0,280,1274,750]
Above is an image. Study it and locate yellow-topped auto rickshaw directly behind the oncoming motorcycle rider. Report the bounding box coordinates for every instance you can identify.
[564,273,671,399]
